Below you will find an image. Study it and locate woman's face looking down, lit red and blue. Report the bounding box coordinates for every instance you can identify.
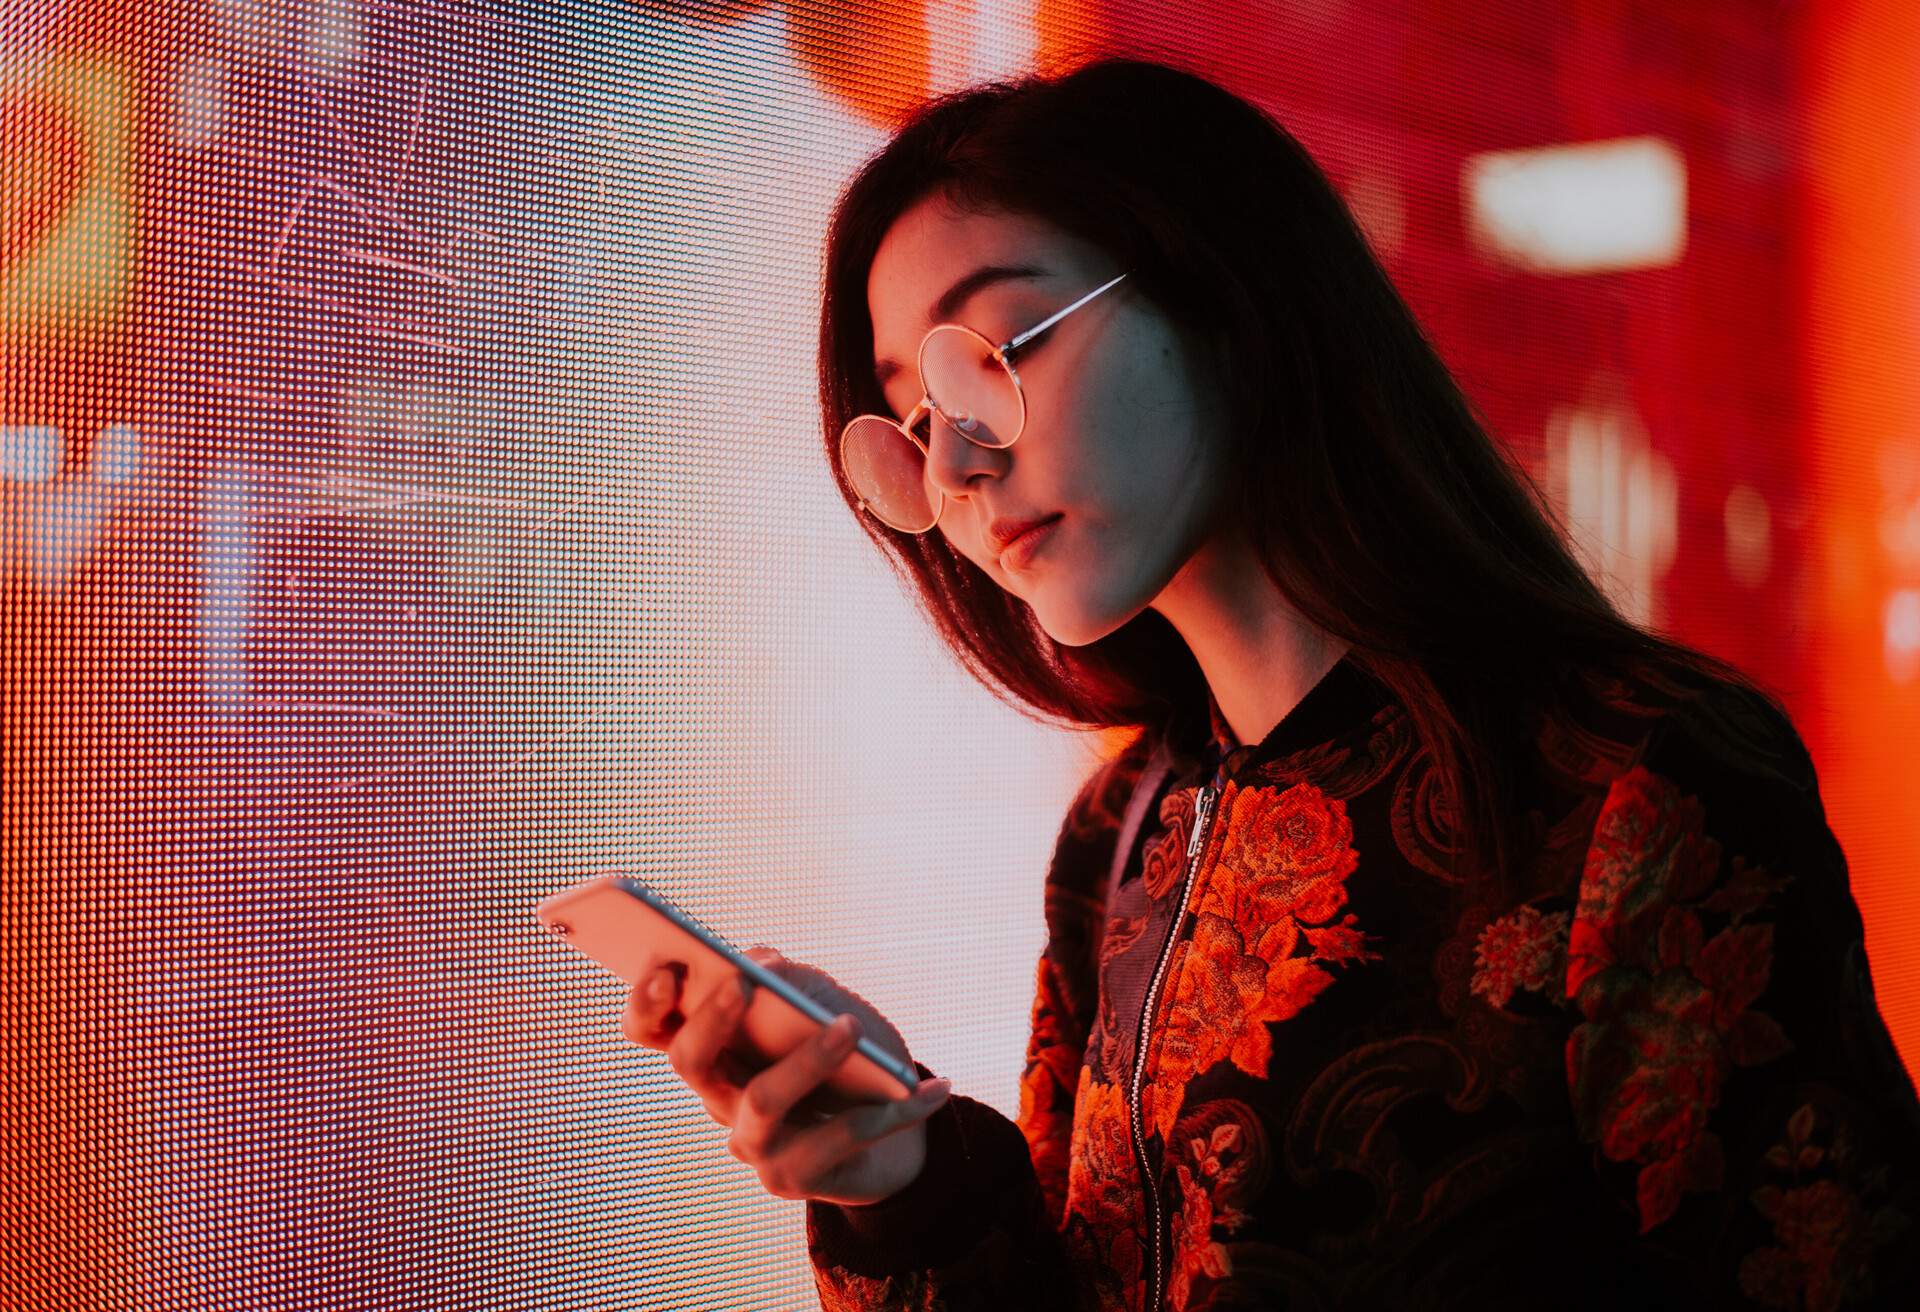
[866,196,1223,647]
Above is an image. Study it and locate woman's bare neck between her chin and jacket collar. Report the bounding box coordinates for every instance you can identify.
[1152,534,1352,745]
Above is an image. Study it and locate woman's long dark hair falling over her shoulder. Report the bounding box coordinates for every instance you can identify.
[820,60,1786,898]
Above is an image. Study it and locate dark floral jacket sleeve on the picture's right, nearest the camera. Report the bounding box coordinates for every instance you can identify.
[1565,693,1920,1308]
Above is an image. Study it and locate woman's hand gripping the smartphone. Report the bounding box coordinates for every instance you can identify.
[620,947,950,1204]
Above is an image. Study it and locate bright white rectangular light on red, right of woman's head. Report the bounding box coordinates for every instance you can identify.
[1461,136,1686,273]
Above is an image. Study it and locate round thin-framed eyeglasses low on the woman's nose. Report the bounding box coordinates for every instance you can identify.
[839,273,1127,534]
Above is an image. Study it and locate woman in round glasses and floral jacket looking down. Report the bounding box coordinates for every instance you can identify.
[624,61,1920,1308]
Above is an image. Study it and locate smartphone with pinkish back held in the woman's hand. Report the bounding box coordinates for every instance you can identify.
[534,874,920,1103]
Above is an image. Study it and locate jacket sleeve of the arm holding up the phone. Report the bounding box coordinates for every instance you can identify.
[806,755,1137,1312]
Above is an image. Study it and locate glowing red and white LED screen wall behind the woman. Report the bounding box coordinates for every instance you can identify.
[0,0,1920,1310]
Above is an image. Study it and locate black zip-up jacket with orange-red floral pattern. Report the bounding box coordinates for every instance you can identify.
[806,655,1920,1312]
